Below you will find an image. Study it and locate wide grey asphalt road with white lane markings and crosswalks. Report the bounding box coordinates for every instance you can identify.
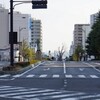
[0,61,100,100]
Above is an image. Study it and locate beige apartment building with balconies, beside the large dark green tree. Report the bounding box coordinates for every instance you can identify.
[73,24,90,51]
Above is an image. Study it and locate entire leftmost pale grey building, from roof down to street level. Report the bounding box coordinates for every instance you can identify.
[0,5,9,60]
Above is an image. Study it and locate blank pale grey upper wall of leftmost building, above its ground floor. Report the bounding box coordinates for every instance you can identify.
[0,6,9,49]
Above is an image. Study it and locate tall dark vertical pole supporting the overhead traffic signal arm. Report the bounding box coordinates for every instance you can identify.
[9,0,14,66]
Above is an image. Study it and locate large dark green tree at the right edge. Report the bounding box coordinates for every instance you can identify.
[86,12,100,59]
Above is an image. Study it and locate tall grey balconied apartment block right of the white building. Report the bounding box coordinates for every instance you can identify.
[31,19,42,51]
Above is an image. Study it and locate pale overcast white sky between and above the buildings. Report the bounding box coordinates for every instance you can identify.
[0,0,100,54]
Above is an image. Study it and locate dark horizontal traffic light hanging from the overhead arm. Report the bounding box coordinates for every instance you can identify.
[32,0,47,9]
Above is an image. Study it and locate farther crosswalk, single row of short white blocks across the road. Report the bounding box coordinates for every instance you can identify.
[0,74,100,79]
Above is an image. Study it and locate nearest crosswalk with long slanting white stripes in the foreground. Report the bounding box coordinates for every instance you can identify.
[0,86,100,100]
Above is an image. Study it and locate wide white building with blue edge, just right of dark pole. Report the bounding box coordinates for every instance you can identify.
[13,12,31,44]
